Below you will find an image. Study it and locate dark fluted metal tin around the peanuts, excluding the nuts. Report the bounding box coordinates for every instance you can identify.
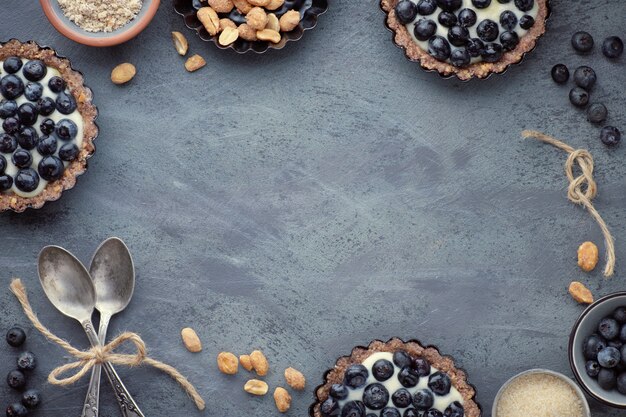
[174,0,328,54]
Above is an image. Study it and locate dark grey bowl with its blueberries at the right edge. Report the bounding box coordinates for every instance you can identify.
[569,292,626,409]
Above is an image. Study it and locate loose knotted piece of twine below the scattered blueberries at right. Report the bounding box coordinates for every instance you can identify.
[522,130,615,277]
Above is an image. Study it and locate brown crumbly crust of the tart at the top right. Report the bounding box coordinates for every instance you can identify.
[380,0,550,81]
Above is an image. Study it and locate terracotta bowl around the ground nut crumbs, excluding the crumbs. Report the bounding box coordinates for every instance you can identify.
[40,0,161,46]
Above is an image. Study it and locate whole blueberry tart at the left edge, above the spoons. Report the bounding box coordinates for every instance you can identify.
[0,40,98,212]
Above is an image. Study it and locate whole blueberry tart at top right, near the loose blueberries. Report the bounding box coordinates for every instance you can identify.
[381,0,550,80]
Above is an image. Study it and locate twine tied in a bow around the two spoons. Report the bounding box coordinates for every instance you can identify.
[10,279,205,410]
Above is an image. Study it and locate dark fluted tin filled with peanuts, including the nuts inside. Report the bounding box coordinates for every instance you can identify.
[174,0,328,54]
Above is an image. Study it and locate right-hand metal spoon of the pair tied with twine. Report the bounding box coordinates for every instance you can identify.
[82,237,135,417]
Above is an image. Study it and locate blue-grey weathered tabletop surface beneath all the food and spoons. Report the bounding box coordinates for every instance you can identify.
[0,0,626,417]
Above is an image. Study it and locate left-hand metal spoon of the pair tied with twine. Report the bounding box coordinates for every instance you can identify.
[38,246,144,417]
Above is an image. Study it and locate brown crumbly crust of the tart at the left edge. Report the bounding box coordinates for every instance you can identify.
[0,39,98,213]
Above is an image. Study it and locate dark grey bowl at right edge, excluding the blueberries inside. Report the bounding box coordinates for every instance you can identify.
[568,292,626,409]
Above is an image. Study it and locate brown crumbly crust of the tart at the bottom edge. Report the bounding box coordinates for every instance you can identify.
[309,338,482,417]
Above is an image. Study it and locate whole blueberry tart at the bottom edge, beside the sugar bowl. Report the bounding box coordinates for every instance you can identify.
[309,338,481,417]
